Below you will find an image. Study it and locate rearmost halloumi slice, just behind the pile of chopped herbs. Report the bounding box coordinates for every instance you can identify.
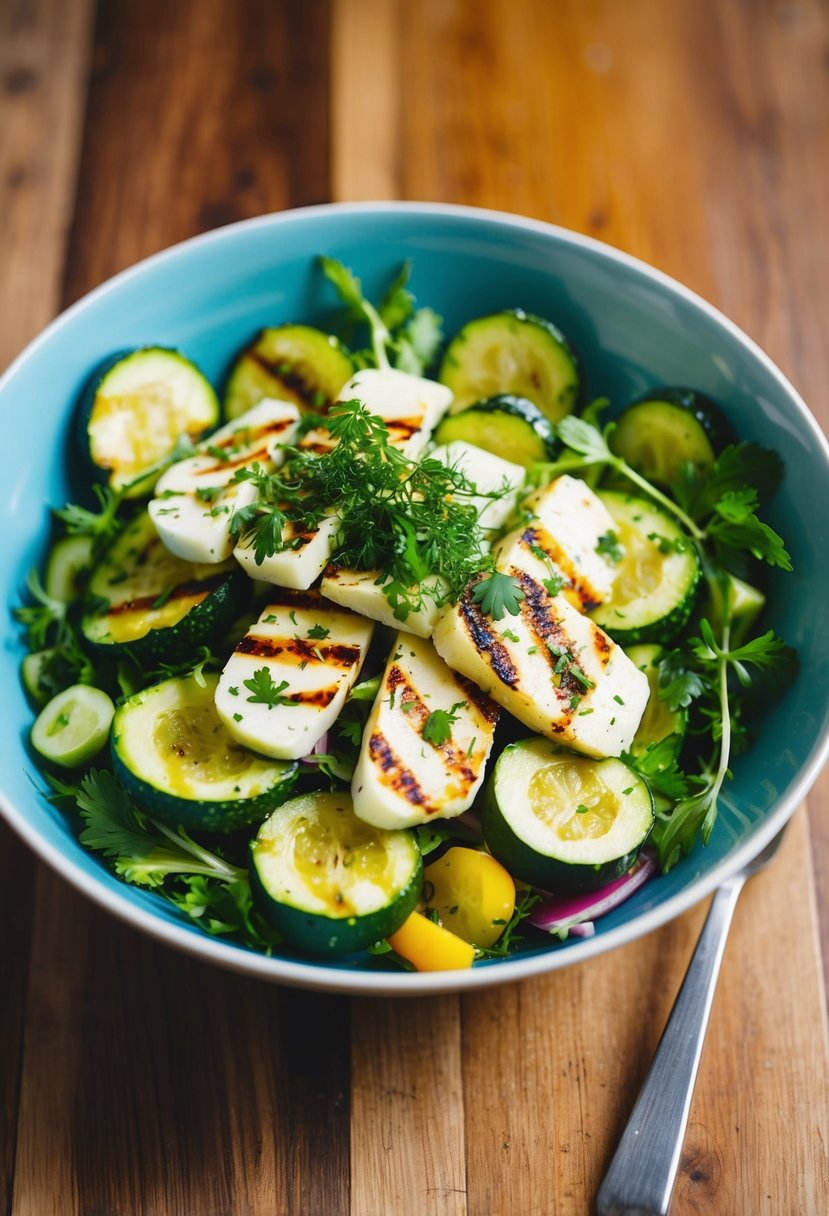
[298,367,452,460]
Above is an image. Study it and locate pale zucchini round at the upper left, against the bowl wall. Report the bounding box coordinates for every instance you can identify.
[78,347,219,497]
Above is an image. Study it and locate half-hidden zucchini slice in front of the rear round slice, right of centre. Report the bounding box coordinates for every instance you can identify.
[434,393,556,468]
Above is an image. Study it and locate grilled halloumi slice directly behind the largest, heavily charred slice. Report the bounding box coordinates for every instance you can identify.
[495,473,616,612]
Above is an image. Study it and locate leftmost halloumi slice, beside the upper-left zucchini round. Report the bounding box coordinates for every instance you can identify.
[148,399,299,562]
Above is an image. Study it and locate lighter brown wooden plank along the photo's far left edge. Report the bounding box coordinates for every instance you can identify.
[0,0,91,1211]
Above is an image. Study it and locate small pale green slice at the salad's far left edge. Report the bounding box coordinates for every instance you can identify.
[32,685,115,769]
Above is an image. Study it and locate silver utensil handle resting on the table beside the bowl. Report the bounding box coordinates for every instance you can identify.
[597,876,744,1216]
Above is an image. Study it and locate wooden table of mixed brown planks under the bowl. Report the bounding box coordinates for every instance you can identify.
[0,0,829,1216]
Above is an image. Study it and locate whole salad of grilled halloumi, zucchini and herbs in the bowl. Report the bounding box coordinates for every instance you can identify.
[16,258,795,970]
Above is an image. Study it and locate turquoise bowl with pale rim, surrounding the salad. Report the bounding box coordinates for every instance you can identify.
[0,203,829,995]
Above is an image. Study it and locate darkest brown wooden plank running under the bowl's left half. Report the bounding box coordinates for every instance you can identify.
[7,0,349,1216]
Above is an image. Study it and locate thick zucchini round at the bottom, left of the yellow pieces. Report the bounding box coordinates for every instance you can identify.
[248,793,423,955]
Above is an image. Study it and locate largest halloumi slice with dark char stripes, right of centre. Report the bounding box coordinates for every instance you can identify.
[433,567,649,758]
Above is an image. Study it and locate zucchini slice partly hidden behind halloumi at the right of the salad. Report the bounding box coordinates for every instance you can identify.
[590,490,700,646]
